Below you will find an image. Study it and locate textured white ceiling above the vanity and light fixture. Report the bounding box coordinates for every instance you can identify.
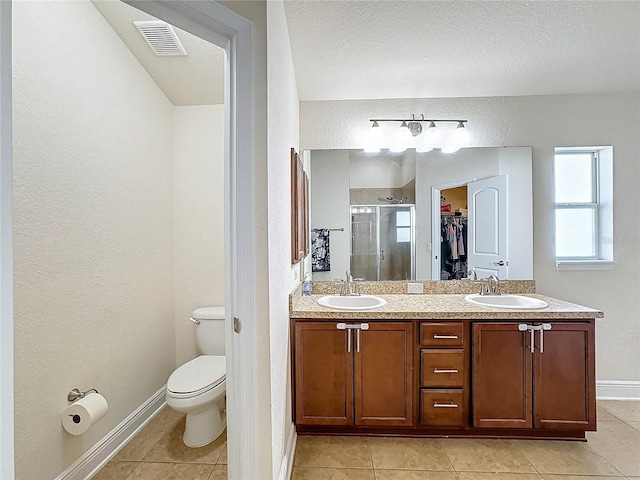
[285,0,640,101]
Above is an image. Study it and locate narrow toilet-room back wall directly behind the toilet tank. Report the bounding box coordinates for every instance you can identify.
[173,105,225,365]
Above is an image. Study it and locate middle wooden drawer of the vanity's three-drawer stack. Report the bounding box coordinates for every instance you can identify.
[420,348,464,387]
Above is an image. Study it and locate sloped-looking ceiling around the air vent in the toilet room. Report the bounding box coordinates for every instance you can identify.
[91,0,224,106]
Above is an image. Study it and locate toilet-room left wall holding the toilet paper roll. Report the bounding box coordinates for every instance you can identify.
[13,1,175,479]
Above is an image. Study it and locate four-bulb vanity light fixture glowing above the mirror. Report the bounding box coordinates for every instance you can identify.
[365,114,471,153]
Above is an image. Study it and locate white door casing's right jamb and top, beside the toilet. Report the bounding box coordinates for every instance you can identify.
[125,0,256,478]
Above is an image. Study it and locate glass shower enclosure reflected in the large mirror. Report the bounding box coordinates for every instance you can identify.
[350,204,415,281]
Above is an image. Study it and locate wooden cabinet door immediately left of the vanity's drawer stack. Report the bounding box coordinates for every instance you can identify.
[354,322,413,426]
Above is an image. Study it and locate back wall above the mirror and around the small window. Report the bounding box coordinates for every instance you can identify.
[300,94,640,385]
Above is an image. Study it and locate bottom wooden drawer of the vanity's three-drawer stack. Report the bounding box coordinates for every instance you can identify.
[420,389,464,427]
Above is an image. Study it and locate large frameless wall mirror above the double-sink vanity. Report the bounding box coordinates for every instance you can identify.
[305,147,533,281]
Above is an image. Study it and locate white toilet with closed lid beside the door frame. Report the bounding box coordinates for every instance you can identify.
[167,307,227,447]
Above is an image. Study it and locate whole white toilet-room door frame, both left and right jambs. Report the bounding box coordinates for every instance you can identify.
[0,0,261,478]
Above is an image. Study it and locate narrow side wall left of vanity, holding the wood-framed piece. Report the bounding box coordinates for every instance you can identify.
[265,1,299,479]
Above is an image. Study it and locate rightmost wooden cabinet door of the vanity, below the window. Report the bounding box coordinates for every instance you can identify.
[533,322,596,430]
